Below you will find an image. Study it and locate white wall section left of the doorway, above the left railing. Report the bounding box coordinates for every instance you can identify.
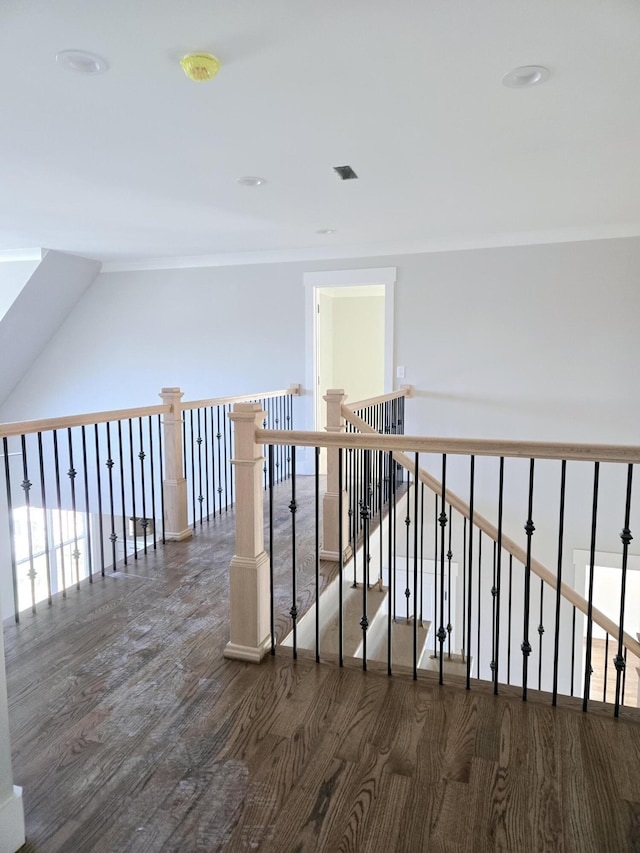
[0,265,304,421]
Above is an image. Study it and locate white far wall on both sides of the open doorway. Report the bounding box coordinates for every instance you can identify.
[6,238,640,443]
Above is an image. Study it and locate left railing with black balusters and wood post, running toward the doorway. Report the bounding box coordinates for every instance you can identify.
[0,386,300,621]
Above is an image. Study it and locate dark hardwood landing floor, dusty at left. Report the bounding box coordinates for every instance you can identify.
[5,484,640,853]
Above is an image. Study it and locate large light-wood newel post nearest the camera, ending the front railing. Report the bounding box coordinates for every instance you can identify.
[224,403,271,663]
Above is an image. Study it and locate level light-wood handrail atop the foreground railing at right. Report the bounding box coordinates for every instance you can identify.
[252,426,640,464]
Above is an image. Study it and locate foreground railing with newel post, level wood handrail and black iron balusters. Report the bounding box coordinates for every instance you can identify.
[227,391,640,715]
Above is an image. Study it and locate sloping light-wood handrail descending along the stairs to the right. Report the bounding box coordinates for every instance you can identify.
[345,413,640,657]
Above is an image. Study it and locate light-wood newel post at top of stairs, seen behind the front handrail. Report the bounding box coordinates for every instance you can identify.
[320,388,351,563]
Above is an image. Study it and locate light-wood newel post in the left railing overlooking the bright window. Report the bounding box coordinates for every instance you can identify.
[160,388,193,541]
